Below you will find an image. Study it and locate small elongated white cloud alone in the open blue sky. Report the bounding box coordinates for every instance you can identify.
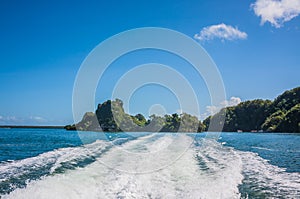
[194,23,248,41]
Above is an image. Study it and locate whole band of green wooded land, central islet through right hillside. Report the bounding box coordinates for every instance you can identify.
[65,87,300,132]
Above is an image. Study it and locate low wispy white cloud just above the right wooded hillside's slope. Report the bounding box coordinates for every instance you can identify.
[200,97,242,120]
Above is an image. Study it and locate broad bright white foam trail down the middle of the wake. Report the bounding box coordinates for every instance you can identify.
[4,135,242,198]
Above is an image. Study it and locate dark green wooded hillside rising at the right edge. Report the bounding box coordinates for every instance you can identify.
[203,87,300,132]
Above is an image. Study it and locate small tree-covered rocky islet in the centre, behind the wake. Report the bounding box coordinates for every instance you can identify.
[65,99,204,132]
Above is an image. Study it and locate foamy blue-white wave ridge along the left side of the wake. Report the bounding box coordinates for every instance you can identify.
[0,134,148,194]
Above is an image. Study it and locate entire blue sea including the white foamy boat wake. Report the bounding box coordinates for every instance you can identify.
[0,128,300,199]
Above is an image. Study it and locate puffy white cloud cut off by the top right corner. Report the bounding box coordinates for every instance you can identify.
[251,0,300,28]
